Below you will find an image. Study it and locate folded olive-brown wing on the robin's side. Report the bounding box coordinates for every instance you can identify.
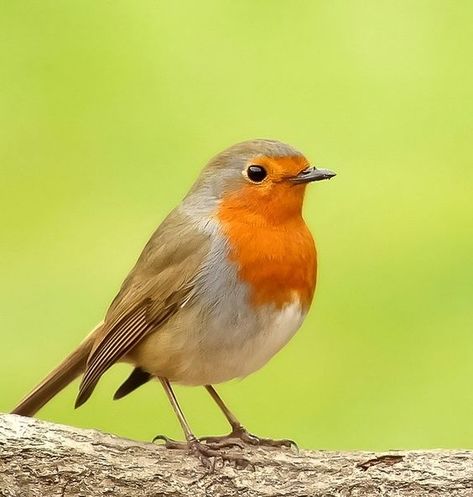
[75,211,209,407]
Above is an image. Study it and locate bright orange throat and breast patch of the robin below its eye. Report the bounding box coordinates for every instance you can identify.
[217,185,317,309]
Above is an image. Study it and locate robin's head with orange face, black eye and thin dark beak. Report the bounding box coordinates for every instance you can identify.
[183,140,335,222]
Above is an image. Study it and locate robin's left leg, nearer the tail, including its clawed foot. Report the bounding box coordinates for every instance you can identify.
[153,378,248,469]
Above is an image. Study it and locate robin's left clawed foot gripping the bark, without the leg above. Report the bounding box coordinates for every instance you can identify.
[153,435,252,471]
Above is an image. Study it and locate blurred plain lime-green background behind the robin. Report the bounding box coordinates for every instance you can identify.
[0,0,473,449]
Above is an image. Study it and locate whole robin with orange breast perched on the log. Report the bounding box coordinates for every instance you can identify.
[12,139,335,461]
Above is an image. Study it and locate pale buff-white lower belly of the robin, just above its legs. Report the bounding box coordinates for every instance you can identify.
[130,300,305,385]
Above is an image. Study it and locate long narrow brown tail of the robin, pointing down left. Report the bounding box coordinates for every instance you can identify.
[12,323,102,416]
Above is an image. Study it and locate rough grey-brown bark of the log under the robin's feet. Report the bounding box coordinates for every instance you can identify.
[0,415,473,497]
